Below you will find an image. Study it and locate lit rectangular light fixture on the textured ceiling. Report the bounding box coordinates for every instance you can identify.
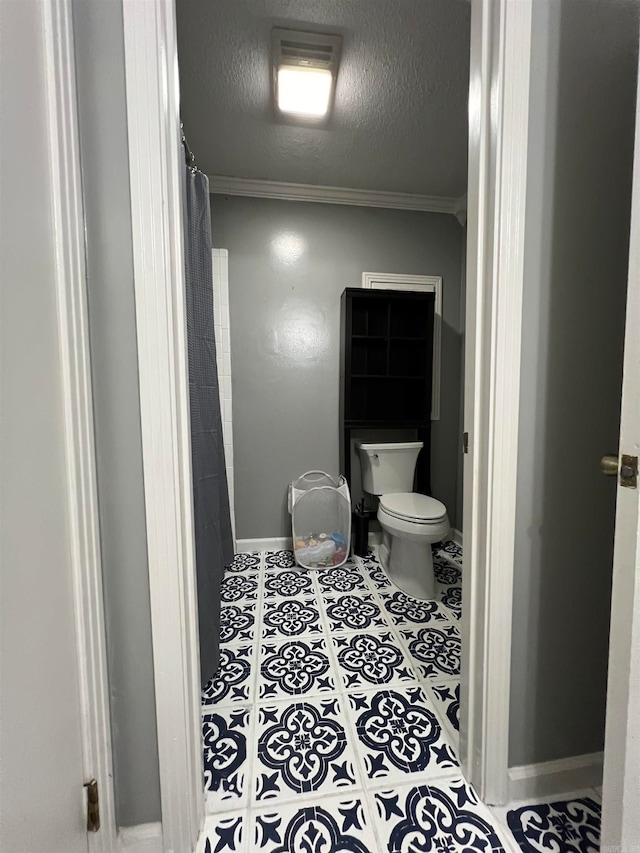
[271,28,342,122]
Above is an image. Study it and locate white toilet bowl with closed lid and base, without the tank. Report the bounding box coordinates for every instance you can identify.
[378,492,451,600]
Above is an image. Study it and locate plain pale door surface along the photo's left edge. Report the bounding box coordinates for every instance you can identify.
[0,0,88,853]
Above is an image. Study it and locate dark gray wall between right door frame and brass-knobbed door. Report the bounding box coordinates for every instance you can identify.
[509,0,638,766]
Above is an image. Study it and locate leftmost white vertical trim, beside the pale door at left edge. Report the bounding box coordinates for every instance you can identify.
[44,0,116,853]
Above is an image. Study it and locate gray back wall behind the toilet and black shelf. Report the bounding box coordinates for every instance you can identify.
[211,195,463,539]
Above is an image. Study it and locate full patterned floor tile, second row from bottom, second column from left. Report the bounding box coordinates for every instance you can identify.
[253,696,358,802]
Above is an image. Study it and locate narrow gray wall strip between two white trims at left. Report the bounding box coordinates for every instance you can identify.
[74,0,160,826]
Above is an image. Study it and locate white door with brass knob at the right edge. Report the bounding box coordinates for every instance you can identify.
[602,60,640,851]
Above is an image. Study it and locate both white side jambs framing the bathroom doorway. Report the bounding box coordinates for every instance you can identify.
[124,0,531,840]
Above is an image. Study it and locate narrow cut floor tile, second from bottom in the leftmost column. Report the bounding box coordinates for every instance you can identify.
[202,707,253,811]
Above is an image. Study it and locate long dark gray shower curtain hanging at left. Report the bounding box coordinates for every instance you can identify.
[185,166,233,686]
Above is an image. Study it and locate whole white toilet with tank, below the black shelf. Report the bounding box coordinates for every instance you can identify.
[356,441,451,600]
